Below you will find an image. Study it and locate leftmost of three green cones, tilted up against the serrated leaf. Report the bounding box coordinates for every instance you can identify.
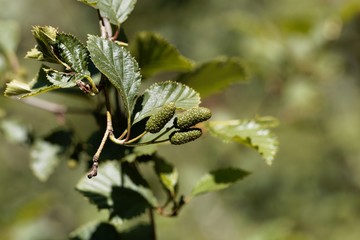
[145,102,176,133]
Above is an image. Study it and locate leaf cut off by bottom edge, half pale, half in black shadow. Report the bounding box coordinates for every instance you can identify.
[69,221,122,240]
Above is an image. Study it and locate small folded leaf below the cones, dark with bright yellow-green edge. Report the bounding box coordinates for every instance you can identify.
[154,158,179,197]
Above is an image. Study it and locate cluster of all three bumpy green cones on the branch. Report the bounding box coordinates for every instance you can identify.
[145,102,211,145]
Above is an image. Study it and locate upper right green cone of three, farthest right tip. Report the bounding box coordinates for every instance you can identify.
[174,107,211,129]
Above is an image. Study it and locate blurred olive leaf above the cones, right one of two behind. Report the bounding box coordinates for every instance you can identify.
[176,58,247,97]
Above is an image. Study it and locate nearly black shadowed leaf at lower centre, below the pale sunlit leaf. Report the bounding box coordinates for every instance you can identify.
[110,187,151,219]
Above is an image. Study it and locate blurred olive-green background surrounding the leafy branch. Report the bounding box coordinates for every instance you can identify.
[0,0,360,240]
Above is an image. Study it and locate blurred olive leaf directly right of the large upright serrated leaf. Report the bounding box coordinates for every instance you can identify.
[131,32,194,77]
